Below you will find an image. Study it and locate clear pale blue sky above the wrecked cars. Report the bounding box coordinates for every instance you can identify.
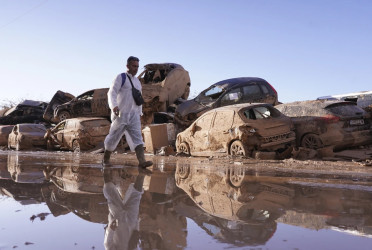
[0,0,372,104]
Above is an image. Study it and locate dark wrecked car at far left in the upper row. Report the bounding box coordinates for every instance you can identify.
[0,100,47,125]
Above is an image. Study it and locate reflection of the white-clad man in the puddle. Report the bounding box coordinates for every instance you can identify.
[103,168,145,249]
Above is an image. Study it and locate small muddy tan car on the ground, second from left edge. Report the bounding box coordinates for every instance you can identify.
[8,123,46,150]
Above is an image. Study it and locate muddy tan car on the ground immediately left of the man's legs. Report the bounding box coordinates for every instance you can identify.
[45,117,111,151]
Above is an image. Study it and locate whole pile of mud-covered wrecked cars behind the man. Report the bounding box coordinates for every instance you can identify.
[0,63,372,159]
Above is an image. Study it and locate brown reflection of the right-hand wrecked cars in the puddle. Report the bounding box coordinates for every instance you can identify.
[175,165,372,246]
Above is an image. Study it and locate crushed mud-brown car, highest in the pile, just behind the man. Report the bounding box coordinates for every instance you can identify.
[138,63,191,124]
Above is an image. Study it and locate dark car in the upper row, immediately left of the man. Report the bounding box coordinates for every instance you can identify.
[53,88,110,121]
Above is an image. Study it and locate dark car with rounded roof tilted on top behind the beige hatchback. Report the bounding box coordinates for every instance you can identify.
[175,77,278,126]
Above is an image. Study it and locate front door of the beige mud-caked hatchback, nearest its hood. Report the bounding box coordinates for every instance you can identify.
[190,112,215,152]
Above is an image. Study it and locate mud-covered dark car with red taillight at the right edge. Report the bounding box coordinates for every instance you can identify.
[276,100,372,150]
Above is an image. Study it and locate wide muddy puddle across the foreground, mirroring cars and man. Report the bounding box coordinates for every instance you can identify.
[0,152,372,249]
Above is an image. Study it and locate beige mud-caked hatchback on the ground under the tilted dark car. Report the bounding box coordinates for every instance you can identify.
[176,103,295,156]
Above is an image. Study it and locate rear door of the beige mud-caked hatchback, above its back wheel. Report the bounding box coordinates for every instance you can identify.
[209,110,235,153]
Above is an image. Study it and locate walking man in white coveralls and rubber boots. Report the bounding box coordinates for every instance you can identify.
[103,56,152,168]
